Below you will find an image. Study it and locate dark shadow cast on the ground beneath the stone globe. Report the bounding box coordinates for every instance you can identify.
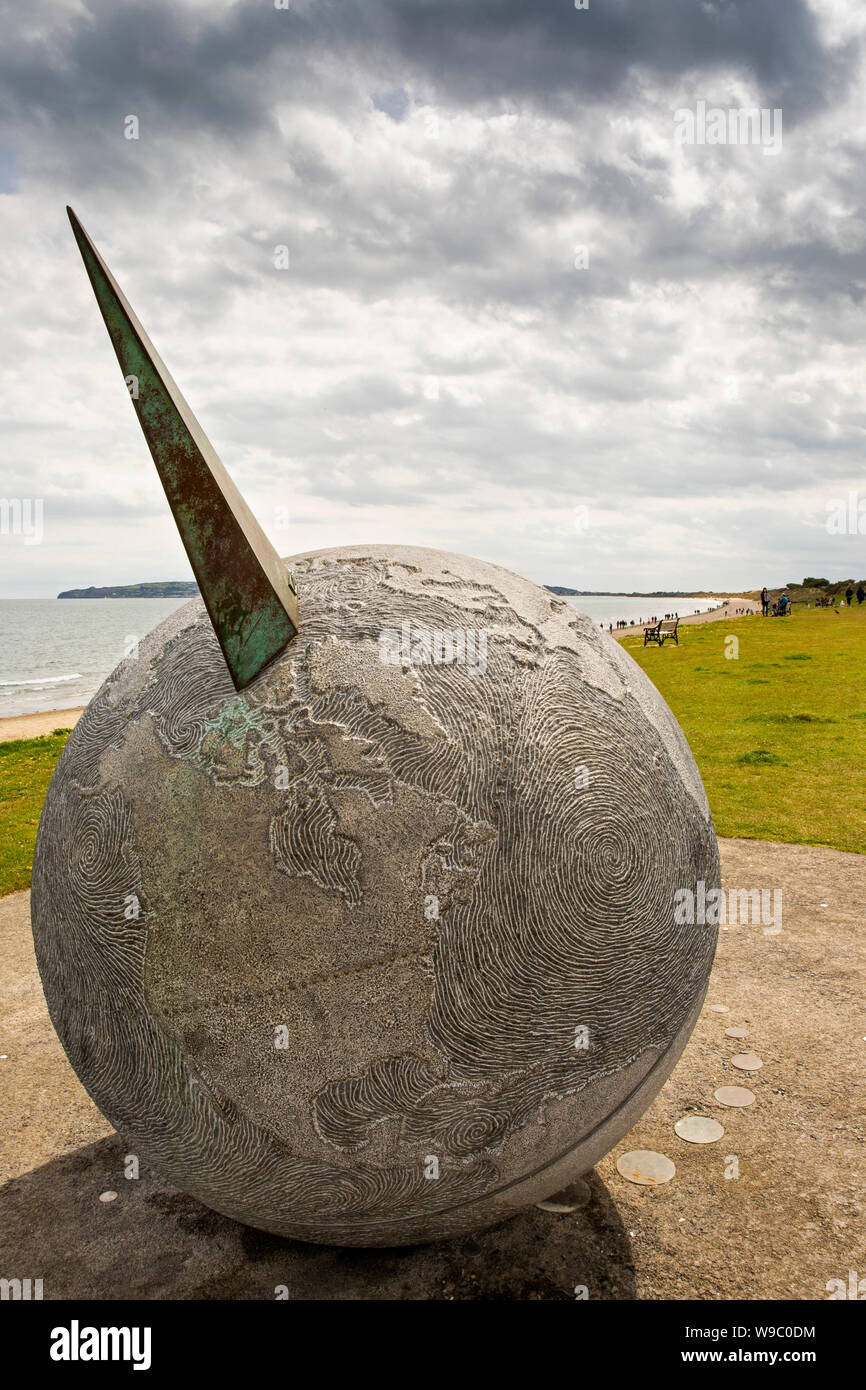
[0,1136,637,1301]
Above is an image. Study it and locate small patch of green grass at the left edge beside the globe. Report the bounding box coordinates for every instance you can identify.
[0,728,70,895]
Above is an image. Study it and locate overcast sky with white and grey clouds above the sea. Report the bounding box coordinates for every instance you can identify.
[0,0,866,598]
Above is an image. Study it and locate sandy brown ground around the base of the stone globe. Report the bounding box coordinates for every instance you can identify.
[0,840,866,1300]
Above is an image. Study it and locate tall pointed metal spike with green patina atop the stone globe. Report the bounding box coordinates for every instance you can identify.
[67,207,297,689]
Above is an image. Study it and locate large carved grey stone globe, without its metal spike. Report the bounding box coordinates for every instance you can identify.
[32,208,720,1245]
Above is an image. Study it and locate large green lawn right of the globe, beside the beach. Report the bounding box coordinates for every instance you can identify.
[623,605,866,853]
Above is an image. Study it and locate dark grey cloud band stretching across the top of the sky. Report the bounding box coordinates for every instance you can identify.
[0,0,853,132]
